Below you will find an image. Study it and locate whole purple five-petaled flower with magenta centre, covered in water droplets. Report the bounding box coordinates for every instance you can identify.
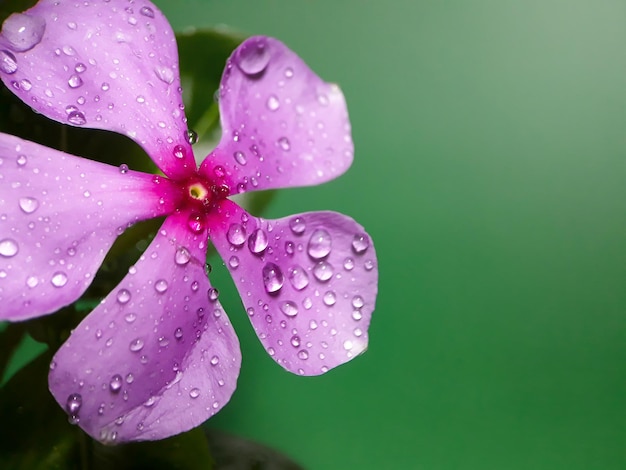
[0,0,378,442]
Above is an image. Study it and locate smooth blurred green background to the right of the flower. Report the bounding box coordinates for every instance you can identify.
[156,0,626,470]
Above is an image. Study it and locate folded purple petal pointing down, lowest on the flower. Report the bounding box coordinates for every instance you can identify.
[49,213,241,443]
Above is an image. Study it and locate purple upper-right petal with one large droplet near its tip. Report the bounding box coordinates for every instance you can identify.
[201,36,353,193]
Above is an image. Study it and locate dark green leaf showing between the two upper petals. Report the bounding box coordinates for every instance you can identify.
[176,29,246,138]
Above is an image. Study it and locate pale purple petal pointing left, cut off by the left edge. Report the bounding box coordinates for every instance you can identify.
[0,134,178,320]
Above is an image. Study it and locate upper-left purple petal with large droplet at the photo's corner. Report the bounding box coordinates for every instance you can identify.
[0,0,195,178]
